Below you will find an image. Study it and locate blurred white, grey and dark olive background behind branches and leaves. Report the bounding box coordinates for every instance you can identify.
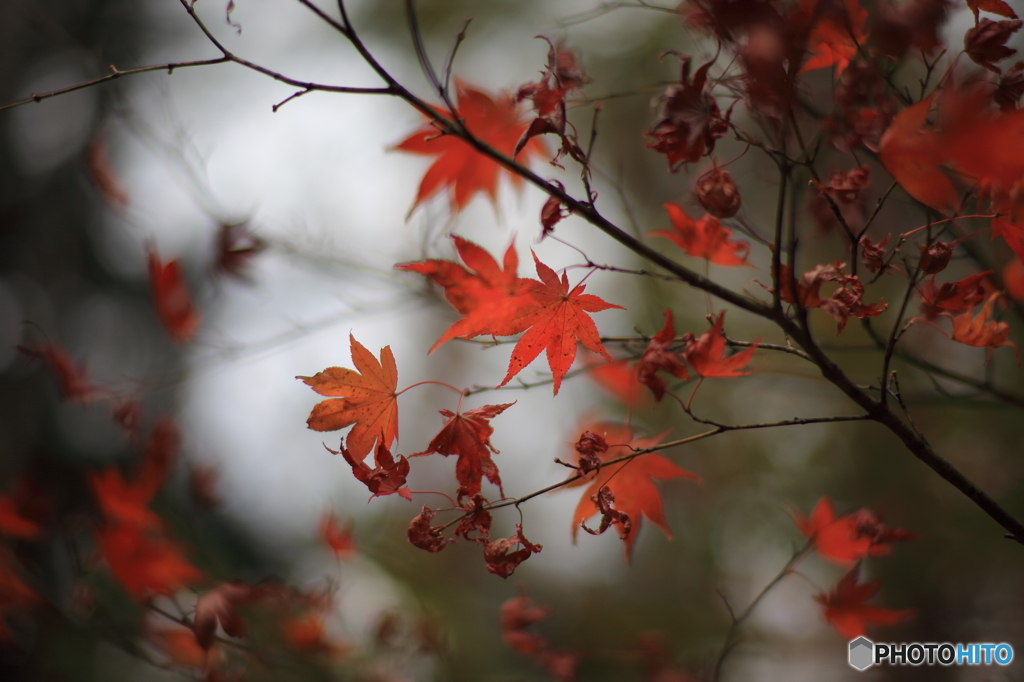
[0,0,1024,682]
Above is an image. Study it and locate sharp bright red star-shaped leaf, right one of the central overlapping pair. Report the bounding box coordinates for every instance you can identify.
[498,254,623,395]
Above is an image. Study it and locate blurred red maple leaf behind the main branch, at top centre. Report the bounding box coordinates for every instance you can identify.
[395,80,547,212]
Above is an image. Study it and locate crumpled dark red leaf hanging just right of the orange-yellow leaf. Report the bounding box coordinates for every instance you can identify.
[413,402,515,498]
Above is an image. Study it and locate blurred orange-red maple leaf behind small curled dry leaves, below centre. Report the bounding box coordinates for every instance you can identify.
[566,423,700,561]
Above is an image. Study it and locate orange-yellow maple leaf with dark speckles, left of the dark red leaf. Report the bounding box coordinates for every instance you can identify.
[296,334,398,460]
